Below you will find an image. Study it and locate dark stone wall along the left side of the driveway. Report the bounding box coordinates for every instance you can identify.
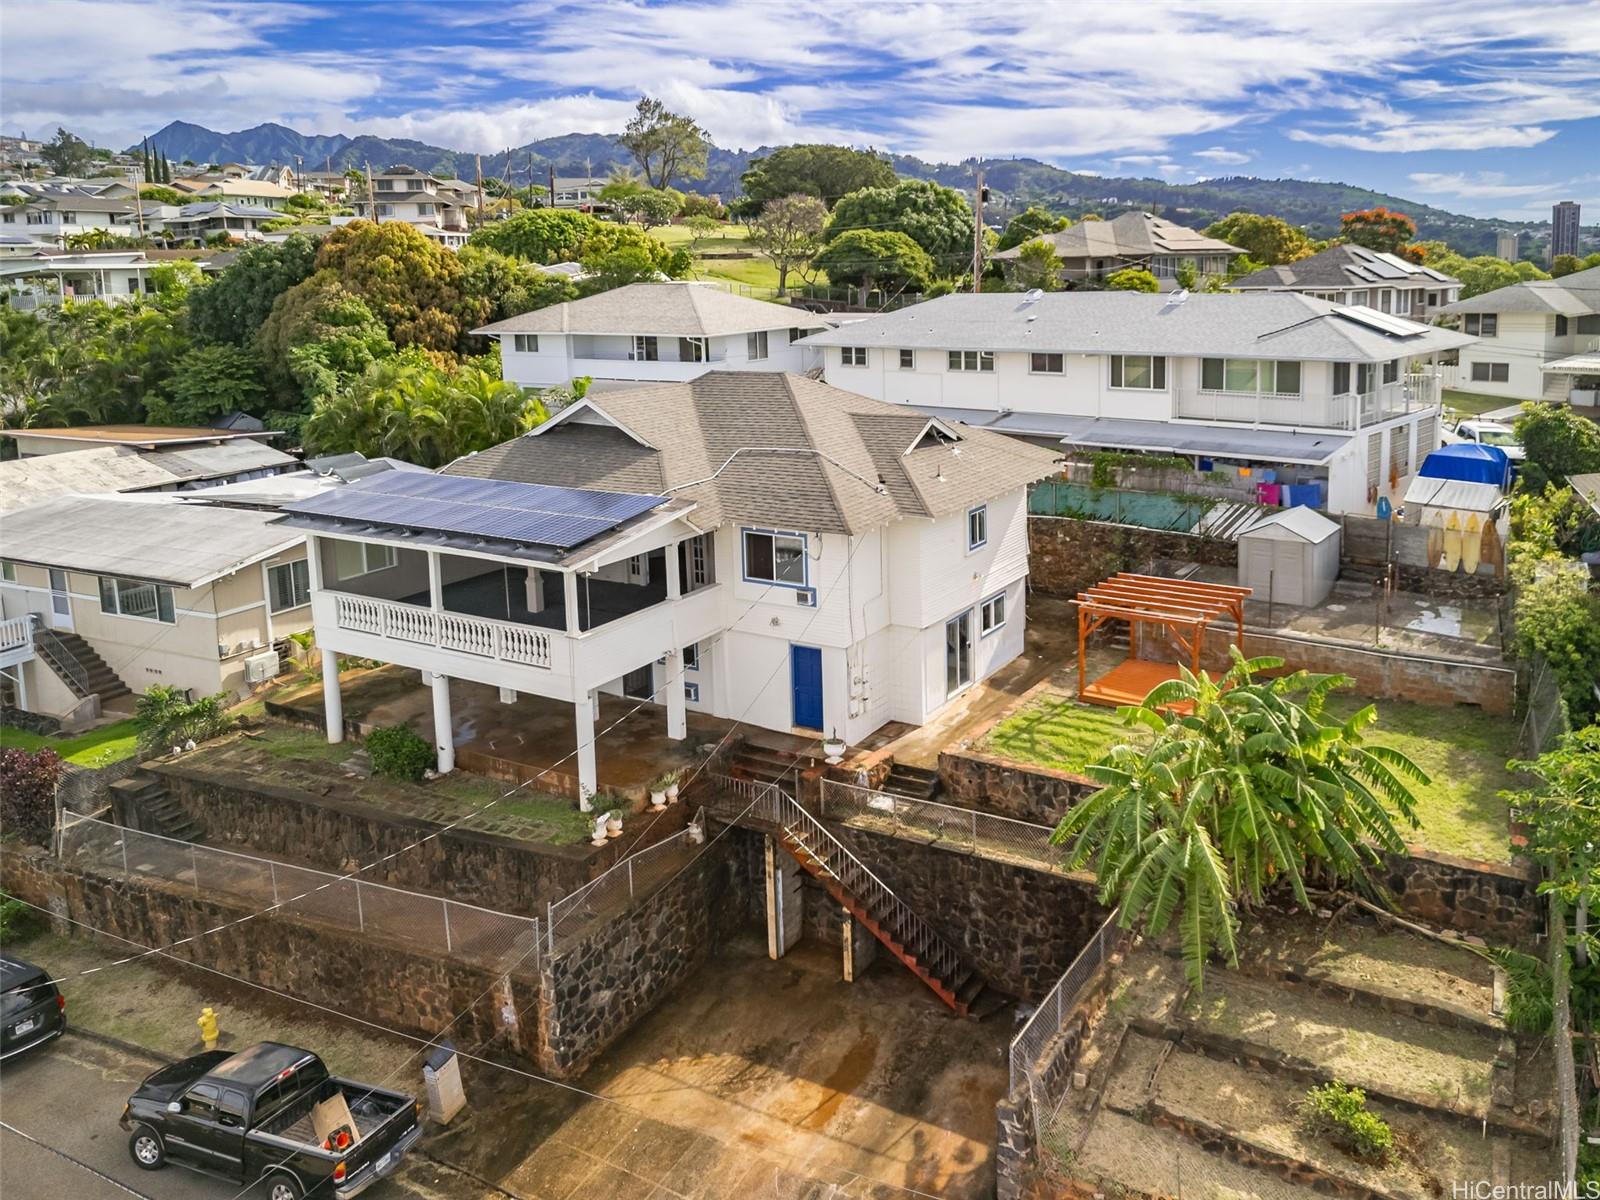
[539,840,744,1078]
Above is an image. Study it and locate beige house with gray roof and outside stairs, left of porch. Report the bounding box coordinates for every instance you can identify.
[0,494,310,725]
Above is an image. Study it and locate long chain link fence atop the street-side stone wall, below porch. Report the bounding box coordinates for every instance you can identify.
[61,818,542,966]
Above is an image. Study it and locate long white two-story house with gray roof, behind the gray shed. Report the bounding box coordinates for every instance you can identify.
[806,291,1470,512]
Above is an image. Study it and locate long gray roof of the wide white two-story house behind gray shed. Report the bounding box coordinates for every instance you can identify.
[805,291,1475,362]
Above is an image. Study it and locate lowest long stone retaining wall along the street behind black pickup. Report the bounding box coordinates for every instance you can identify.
[0,845,542,1066]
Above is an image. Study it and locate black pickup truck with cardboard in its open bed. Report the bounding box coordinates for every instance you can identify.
[122,1042,422,1200]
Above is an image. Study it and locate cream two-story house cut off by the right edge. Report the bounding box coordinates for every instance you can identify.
[1443,267,1600,405]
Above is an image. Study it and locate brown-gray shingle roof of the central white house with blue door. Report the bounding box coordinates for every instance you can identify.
[445,371,1056,533]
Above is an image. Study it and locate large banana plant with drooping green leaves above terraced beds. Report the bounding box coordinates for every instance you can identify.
[1051,646,1427,987]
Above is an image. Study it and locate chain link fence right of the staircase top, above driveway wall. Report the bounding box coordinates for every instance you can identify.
[818,779,1067,874]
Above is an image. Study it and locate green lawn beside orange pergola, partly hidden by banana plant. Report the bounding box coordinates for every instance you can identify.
[978,694,1518,862]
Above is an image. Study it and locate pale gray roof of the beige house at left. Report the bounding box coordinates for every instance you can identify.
[5,496,301,587]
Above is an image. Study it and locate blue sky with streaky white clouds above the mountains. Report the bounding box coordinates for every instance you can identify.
[0,0,1600,219]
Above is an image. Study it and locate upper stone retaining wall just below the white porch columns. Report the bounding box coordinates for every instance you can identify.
[144,763,627,917]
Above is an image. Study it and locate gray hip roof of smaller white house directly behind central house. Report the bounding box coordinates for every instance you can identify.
[474,283,822,338]
